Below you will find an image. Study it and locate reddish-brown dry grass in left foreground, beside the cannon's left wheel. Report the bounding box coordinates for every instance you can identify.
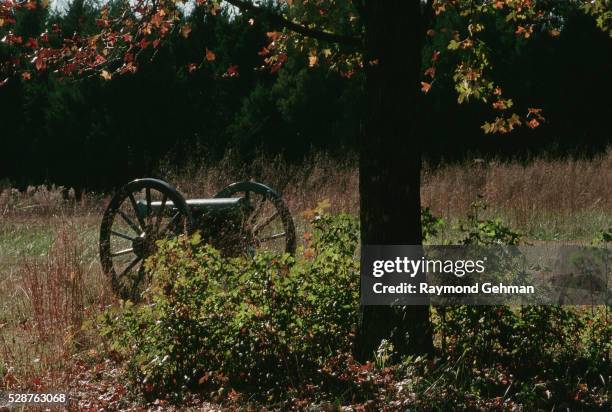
[0,220,113,389]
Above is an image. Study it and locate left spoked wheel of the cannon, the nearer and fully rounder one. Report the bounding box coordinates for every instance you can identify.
[100,179,193,300]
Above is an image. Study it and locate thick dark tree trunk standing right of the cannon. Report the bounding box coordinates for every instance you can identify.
[355,0,433,360]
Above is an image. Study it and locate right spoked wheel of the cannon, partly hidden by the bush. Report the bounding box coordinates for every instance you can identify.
[215,182,296,255]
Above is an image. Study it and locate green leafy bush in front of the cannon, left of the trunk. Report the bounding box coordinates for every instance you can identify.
[106,215,359,398]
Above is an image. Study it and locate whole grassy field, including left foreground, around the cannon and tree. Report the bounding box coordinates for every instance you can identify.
[0,151,612,408]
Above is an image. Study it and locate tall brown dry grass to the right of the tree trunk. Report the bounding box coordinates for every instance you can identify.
[422,151,612,222]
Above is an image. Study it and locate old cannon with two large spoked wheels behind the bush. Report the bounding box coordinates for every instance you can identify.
[100,178,296,300]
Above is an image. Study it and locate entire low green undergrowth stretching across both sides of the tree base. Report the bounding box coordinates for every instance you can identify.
[105,209,612,410]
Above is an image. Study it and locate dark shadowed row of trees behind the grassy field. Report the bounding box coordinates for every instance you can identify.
[0,0,612,190]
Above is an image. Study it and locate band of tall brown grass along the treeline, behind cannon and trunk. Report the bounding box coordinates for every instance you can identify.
[0,149,612,235]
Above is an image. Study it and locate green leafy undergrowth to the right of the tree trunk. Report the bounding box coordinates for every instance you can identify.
[434,211,612,409]
